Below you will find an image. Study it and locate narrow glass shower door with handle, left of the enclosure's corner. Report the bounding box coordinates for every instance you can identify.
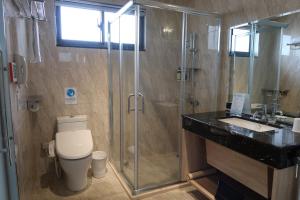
[119,7,135,186]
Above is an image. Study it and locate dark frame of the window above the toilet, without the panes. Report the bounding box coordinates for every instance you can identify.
[55,3,146,51]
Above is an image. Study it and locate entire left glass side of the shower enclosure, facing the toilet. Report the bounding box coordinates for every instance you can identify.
[107,11,135,187]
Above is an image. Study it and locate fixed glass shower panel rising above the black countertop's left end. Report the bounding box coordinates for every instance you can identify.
[184,15,220,113]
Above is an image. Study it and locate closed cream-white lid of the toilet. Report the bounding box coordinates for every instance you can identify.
[55,130,93,159]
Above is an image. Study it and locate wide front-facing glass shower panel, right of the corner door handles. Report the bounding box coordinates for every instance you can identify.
[138,5,182,188]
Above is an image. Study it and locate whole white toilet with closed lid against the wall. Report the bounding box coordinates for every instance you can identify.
[55,115,93,191]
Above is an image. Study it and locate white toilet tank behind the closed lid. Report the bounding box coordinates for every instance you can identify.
[57,115,87,132]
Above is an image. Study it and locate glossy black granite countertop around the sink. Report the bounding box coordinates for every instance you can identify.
[182,111,300,169]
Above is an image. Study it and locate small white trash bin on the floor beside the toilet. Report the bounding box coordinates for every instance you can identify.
[92,151,107,178]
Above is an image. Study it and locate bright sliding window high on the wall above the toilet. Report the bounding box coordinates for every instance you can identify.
[56,3,145,50]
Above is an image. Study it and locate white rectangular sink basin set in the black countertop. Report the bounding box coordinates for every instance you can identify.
[219,117,277,132]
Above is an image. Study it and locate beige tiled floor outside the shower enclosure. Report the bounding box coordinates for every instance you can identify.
[30,168,206,200]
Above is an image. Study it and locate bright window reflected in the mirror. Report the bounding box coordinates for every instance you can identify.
[230,27,259,57]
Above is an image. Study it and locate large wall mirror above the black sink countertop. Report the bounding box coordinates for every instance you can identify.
[228,12,300,117]
